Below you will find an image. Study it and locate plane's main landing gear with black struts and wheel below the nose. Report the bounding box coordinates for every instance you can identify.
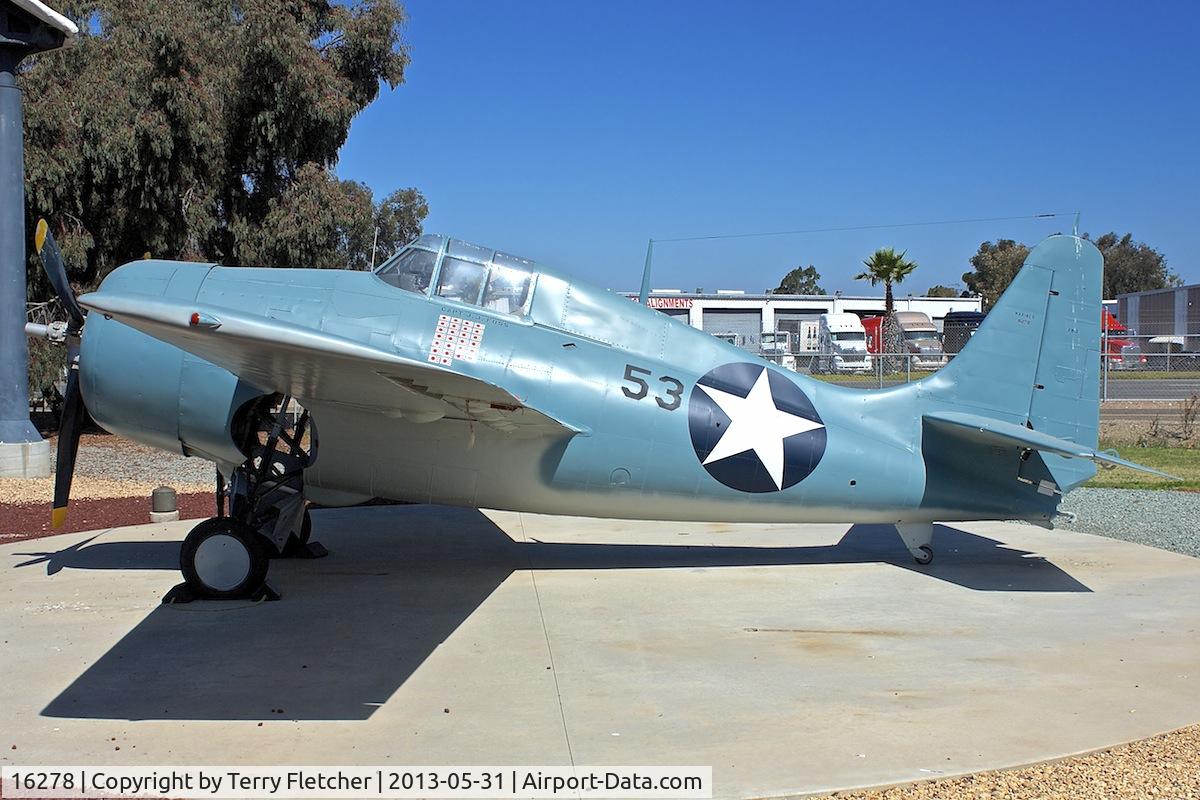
[166,396,328,602]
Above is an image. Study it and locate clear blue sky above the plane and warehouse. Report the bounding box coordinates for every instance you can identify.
[337,0,1200,294]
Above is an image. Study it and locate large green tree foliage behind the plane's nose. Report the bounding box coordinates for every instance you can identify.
[20,0,427,296]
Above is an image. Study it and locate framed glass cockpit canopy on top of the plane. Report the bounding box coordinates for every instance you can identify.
[376,234,536,317]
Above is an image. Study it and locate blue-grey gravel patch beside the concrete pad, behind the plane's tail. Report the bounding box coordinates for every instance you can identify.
[1060,489,1200,557]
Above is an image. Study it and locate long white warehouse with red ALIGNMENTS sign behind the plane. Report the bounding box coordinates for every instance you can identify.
[624,289,983,350]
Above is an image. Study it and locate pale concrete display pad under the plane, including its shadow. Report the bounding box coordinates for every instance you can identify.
[0,506,1200,798]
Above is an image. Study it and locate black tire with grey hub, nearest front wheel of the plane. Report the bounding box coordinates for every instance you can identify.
[179,517,270,600]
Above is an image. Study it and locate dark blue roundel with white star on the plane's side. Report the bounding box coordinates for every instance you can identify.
[688,363,826,493]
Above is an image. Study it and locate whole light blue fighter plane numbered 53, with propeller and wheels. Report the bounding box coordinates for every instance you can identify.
[37,223,1154,599]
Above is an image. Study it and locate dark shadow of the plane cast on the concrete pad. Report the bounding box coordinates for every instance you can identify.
[16,506,1090,720]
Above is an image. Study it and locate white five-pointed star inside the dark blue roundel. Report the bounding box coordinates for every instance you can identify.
[696,369,824,489]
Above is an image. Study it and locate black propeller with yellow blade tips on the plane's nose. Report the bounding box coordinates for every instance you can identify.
[34,219,88,528]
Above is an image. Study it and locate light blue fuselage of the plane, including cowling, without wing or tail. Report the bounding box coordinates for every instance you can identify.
[80,247,1048,523]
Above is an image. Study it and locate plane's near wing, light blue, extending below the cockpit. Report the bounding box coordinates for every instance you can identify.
[79,291,583,434]
